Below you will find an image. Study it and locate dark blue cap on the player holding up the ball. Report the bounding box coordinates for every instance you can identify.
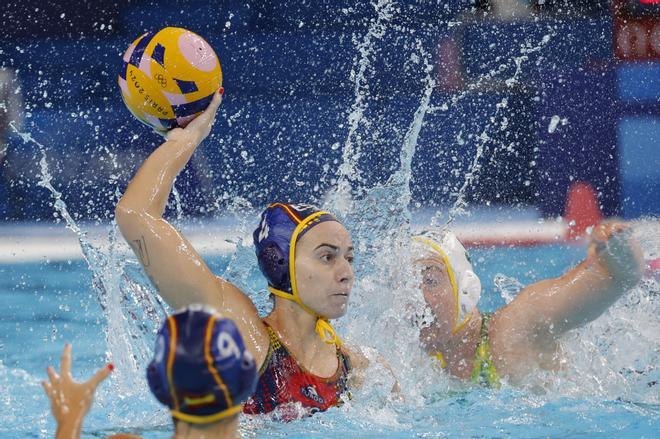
[252,203,337,294]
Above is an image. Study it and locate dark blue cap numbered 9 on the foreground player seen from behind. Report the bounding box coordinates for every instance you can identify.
[147,305,257,424]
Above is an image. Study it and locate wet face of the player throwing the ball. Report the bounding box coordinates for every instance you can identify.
[295,221,354,319]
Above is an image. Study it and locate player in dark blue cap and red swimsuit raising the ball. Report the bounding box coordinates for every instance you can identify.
[115,93,366,416]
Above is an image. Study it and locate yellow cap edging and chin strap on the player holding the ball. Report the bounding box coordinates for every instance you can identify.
[268,211,342,347]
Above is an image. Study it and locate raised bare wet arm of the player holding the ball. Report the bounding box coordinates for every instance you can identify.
[115,89,269,365]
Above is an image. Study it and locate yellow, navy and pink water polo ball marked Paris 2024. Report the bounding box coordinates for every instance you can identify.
[119,27,222,131]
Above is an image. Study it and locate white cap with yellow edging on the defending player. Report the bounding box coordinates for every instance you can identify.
[413,230,481,333]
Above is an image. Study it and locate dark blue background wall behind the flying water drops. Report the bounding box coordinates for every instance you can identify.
[0,0,660,220]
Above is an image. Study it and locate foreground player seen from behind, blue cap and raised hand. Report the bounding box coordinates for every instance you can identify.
[43,305,257,439]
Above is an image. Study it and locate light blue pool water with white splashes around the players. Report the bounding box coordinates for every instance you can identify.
[0,230,660,438]
